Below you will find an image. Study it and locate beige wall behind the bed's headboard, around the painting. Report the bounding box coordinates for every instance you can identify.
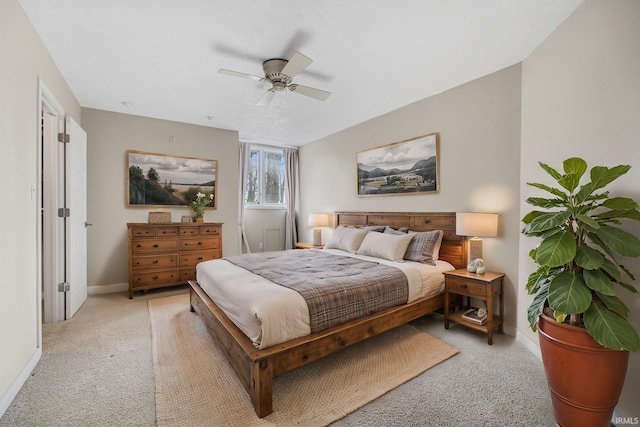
[298,65,521,333]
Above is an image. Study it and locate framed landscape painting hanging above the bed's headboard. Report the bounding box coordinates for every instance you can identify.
[356,133,440,196]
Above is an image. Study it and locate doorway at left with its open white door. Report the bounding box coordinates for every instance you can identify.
[37,82,87,324]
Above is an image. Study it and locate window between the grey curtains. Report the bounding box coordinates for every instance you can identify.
[244,146,287,208]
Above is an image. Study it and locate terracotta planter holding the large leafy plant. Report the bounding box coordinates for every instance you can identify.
[538,315,629,427]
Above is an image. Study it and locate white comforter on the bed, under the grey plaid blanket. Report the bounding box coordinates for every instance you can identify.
[196,249,454,349]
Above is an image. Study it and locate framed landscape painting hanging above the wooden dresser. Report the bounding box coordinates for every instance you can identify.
[127,150,218,209]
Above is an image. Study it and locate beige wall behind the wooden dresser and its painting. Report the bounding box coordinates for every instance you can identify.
[82,108,238,292]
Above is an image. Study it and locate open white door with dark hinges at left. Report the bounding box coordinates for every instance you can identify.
[65,117,88,319]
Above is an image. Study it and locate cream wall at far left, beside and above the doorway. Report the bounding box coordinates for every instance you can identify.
[0,0,80,415]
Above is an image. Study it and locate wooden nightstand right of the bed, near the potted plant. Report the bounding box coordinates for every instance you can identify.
[444,269,504,345]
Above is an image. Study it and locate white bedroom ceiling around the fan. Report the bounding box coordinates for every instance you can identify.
[19,0,582,146]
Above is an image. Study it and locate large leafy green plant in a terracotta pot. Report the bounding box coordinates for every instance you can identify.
[522,157,640,427]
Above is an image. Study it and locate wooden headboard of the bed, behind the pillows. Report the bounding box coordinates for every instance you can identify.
[336,212,467,268]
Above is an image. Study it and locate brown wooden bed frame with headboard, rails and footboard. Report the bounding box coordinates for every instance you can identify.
[189,212,467,418]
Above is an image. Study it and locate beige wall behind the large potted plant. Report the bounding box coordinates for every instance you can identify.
[518,0,640,416]
